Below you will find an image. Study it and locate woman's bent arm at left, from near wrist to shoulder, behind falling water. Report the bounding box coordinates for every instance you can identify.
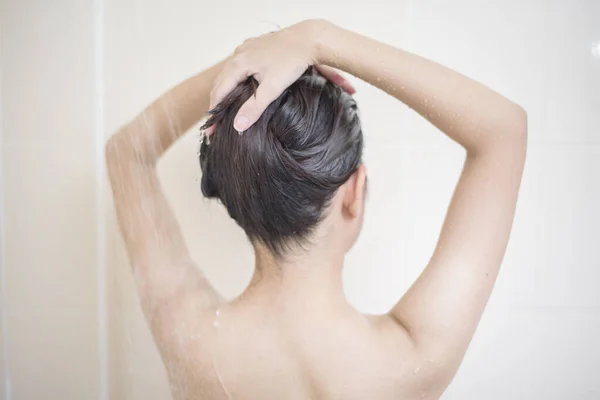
[106,63,222,343]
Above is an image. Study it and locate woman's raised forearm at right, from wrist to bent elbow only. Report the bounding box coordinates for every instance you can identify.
[310,20,525,152]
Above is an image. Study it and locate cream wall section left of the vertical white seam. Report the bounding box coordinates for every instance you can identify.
[0,0,100,399]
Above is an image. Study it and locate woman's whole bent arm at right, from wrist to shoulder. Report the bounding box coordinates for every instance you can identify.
[312,21,527,382]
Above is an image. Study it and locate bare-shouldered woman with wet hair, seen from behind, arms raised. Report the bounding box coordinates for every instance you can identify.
[106,20,527,399]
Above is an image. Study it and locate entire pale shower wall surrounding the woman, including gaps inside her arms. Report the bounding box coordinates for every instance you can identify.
[0,0,600,400]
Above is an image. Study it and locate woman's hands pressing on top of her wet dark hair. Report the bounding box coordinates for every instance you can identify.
[206,20,355,135]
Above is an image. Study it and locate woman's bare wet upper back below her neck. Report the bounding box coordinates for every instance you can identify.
[169,292,427,400]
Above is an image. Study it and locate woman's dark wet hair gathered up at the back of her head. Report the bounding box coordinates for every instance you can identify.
[200,67,363,257]
